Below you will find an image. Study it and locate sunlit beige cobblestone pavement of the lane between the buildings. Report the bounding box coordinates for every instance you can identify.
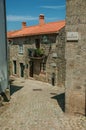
[0,79,86,130]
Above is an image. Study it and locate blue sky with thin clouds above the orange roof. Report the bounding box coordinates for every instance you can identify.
[6,0,66,31]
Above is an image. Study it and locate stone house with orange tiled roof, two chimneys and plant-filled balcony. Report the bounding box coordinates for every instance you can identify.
[8,14,65,86]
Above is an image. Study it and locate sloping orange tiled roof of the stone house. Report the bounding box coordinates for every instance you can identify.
[7,21,65,38]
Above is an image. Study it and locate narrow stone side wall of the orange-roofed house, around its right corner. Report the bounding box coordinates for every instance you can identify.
[57,28,66,87]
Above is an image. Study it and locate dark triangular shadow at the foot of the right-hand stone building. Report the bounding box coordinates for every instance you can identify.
[51,93,65,112]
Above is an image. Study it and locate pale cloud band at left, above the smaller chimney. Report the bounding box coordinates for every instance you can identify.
[7,15,38,22]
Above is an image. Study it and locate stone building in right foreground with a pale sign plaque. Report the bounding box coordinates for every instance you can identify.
[65,0,86,115]
